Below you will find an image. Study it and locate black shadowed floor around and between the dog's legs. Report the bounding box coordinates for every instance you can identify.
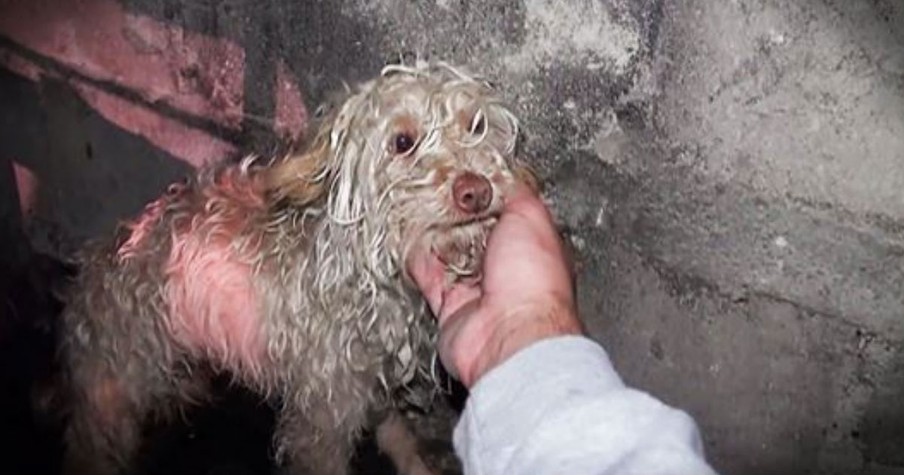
[0,251,455,475]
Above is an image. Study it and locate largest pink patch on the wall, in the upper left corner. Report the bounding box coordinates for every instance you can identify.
[0,0,244,127]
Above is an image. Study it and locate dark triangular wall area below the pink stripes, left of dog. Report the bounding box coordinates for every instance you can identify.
[0,65,192,256]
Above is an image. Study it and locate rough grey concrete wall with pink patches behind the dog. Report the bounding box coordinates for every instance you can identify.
[0,0,904,474]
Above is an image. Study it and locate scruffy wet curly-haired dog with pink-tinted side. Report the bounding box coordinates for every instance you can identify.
[61,64,532,475]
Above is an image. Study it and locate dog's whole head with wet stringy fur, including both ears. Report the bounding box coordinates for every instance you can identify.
[272,60,536,282]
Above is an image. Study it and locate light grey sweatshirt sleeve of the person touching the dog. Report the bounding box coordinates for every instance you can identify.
[454,336,715,475]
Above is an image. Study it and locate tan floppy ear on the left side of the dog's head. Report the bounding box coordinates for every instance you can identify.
[266,122,331,206]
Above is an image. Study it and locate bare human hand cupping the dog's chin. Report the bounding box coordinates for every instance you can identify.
[408,186,583,388]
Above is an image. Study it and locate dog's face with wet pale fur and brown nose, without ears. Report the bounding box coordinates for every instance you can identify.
[353,68,518,275]
